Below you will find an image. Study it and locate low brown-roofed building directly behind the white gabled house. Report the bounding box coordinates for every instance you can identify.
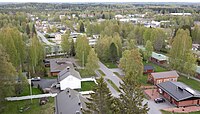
[49,58,74,76]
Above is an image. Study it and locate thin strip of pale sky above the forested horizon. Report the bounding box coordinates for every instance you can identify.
[0,0,200,3]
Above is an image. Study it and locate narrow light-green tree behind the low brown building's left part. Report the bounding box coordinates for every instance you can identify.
[61,34,70,54]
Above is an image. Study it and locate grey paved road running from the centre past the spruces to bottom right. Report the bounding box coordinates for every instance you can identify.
[99,62,168,114]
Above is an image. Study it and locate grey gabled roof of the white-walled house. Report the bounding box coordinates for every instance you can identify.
[58,67,81,81]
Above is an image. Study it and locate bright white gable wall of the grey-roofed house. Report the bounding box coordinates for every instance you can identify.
[60,75,81,90]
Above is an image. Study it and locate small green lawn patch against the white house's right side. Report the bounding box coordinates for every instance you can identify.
[81,81,96,91]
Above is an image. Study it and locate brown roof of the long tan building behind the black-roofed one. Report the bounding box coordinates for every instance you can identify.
[151,71,179,79]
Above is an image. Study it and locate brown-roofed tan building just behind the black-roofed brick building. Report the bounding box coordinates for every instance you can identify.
[148,71,179,85]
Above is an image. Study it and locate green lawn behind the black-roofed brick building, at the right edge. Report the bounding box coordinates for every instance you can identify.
[178,76,200,91]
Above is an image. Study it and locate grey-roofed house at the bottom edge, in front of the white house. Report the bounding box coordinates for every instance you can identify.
[55,88,88,114]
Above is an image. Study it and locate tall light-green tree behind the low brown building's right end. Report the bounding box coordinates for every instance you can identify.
[75,36,91,67]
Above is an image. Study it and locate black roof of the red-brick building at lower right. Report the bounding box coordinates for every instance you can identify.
[157,81,200,101]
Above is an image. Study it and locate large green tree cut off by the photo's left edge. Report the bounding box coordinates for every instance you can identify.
[0,45,17,112]
